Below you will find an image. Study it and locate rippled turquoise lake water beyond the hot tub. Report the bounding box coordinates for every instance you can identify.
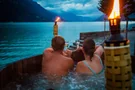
[0,22,135,68]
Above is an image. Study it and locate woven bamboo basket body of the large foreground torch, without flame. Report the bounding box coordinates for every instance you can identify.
[104,38,132,90]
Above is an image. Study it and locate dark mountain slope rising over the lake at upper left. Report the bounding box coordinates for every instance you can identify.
[0,0,57,22]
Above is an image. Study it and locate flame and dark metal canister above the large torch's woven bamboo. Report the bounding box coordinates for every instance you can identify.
[108,0,124,42]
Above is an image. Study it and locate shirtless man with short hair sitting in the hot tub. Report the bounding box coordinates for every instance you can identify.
[42,36,74,80]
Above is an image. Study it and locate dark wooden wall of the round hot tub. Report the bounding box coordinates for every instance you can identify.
[0,55,135,90]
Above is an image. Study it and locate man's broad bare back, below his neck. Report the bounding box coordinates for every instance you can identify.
[42,49,73,78]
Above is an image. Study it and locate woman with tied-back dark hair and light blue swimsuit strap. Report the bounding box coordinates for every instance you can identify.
[75,38,104,75]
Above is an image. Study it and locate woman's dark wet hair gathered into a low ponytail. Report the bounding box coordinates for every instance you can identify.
[83,38,95,61]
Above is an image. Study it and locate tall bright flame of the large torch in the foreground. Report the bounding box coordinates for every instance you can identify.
[109,0,120,19]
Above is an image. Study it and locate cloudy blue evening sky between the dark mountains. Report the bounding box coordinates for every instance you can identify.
[33,0,102,17]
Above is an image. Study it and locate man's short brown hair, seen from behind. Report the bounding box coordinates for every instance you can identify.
[52,36,65,51]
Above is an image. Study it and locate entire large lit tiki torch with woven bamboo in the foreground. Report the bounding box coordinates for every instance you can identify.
[104,0,132,90]
